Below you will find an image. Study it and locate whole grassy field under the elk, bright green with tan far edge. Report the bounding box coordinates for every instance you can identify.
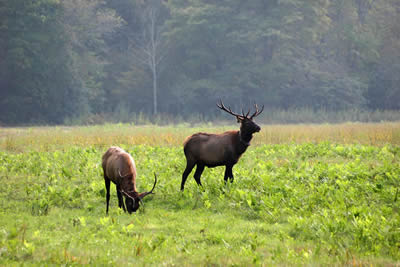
[0,123,400,266]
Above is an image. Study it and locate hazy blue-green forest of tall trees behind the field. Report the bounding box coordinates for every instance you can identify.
[0,0,400,125]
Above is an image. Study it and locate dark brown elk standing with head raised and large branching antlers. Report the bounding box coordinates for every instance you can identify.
[181,100,264,190]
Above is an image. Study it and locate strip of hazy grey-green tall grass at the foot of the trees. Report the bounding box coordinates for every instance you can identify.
[64,108,400,126]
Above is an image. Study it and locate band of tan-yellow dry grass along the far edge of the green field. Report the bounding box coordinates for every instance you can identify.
[0,122,400,151]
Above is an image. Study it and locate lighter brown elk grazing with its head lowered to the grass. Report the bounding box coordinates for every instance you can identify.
[102,146,157,214]
